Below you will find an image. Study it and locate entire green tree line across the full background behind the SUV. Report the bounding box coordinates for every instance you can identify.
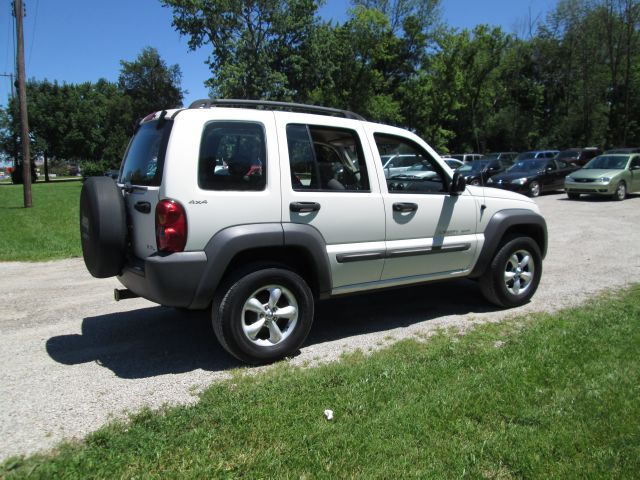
[2,0,640,180]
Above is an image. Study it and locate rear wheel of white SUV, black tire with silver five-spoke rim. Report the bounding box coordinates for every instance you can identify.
[211,267,314,364]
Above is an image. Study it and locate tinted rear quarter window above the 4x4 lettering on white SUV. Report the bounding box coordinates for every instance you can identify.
[198,122,267,190]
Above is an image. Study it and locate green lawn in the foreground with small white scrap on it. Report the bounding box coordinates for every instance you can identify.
[0,286,640,479]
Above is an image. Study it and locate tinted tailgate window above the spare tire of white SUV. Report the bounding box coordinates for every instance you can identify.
[120,120,173,187]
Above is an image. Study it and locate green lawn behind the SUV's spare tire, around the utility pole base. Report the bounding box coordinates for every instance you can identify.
[0,181,82,261]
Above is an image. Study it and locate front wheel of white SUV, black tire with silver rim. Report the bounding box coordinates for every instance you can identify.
[479,237,542,307]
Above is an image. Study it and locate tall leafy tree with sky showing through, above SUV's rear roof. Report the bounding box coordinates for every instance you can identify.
[162,0,319,100]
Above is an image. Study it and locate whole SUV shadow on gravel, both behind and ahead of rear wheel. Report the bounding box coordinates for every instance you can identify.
[46,280,494,379]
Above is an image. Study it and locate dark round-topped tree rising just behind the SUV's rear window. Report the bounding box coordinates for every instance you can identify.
[118,47,183,118]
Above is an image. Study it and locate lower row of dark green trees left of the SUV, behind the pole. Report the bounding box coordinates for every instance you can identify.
[0,47,183,181]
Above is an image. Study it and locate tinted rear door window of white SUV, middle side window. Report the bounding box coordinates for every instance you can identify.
[287,124,369,191]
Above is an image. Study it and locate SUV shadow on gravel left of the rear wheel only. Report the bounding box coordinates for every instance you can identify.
[46,306,241,379]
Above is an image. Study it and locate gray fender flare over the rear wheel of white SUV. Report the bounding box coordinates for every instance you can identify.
[190,223,331,309]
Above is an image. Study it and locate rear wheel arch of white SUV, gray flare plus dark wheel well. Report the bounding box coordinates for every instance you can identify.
[190,223,331,308]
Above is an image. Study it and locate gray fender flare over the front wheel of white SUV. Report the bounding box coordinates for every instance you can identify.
[469,208,548,278]
